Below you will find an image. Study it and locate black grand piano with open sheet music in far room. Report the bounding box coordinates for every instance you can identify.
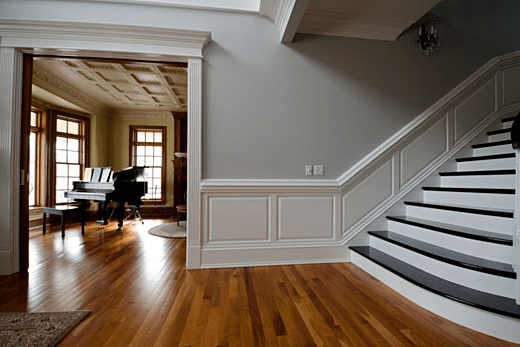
[65,166,148,230]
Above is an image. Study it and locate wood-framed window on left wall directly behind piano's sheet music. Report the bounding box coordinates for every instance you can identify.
[55,114,88,204]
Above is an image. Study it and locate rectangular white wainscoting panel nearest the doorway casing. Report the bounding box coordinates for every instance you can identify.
[207,197,270,244]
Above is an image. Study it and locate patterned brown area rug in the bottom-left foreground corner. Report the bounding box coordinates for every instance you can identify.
[0,311,90,347]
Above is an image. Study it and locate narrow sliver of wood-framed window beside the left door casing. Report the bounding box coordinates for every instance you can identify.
[29,108,43,207]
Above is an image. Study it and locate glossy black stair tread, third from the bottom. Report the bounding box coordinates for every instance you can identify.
[386,216,513,246]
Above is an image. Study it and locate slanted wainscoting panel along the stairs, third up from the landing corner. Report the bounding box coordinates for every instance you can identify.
[454,77,497,142]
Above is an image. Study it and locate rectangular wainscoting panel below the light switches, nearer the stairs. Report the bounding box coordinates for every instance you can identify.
[278,196,336,240]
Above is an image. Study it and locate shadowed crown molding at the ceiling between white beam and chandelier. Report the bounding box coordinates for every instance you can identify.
[298,10,410,41]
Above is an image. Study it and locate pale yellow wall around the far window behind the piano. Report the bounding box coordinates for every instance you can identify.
[107,115,175,206]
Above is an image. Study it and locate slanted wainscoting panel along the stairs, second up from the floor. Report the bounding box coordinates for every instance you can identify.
[399,115,448,187]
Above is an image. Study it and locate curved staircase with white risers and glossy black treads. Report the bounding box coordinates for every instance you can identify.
[350,118,520,343]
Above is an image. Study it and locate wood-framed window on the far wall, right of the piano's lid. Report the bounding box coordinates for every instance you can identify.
[130,125,166,203]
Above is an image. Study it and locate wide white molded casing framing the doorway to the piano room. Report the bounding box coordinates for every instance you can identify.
[0,19,211,275]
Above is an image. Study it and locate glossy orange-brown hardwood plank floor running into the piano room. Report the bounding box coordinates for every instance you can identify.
[0,220,516,347]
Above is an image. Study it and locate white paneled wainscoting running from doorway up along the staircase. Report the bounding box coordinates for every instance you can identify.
[201,52,520,267]
